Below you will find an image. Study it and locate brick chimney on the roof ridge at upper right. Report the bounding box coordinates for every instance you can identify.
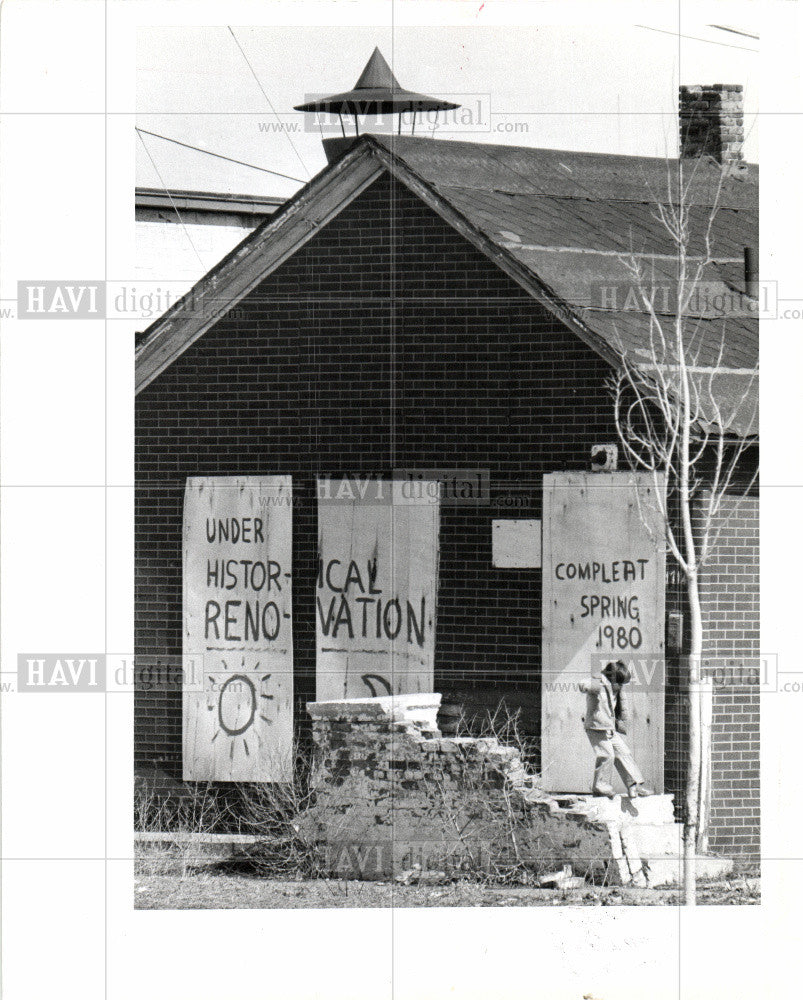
[680,83,744,167]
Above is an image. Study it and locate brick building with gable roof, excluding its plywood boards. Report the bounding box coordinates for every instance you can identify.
[135,103,759,856]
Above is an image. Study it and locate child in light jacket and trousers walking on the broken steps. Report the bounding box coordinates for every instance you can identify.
[580,660,653,799]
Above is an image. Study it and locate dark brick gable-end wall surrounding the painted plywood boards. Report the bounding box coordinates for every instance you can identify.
[135,170,760,860]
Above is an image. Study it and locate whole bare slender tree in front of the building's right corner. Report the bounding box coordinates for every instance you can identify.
[610,161,758,905]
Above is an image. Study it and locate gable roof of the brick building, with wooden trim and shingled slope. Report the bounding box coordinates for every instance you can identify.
[137,135,758,435]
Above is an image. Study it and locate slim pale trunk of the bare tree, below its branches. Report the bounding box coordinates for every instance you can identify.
[683,572,703,906]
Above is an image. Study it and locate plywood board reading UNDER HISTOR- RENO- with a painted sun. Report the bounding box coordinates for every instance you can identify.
[184,476,293,781]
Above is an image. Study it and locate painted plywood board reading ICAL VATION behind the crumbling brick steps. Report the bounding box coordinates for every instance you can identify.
[315,479,440,701]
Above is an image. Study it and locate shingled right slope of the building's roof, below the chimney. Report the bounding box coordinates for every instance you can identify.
[372,136,758,434]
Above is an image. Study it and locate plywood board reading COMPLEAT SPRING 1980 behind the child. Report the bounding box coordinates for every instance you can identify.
[541,472,666,792]
